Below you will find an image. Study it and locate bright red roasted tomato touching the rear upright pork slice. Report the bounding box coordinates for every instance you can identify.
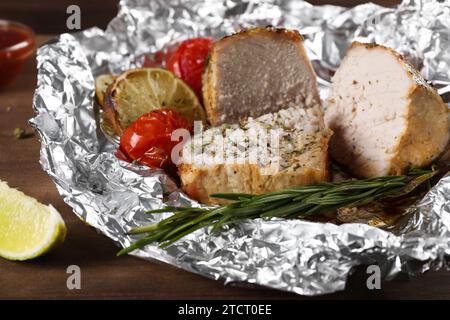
[166,38,214,98]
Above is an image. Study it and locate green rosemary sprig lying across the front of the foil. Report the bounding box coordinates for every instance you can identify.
[118,167,438,255]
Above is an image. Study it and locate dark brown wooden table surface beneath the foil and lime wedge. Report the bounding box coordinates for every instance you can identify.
[0,31,450,299]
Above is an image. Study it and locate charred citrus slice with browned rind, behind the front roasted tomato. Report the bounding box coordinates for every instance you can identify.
[104,68,206,134]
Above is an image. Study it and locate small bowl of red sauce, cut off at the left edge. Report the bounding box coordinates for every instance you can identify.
[0,19,36,87]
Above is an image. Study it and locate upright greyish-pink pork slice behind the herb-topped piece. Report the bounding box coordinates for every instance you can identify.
[203,27,320,125]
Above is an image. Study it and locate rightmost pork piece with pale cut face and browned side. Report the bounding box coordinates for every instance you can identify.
[325,42,449,177]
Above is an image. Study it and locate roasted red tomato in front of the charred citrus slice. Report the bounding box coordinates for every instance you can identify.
[116,109,192,168]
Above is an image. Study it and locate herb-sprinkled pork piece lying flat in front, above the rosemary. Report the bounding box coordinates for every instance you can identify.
[179,106,330,203]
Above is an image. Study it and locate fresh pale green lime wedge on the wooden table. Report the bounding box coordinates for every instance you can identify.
[0,180,66,260]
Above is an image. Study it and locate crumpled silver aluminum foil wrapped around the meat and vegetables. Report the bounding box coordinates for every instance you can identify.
[31,0,450,295]
